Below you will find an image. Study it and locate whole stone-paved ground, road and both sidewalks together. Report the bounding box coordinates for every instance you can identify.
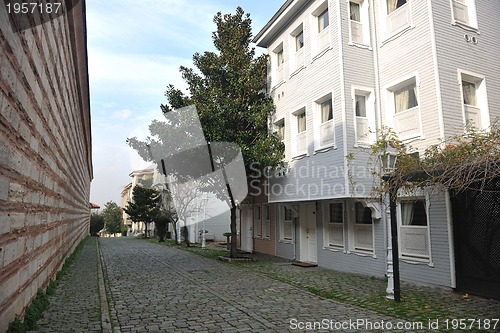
[32,238,500,333]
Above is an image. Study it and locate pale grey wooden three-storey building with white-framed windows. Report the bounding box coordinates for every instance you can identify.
[250,0,500,296]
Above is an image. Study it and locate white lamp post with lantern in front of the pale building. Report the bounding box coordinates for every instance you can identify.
[380,151,401,302]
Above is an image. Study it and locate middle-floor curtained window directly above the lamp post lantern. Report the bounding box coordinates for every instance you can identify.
[389,77,422,140]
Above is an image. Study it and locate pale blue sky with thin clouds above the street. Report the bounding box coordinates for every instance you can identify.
[86,0,285,207]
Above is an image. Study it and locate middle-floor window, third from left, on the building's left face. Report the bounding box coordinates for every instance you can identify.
[314,94,335,149]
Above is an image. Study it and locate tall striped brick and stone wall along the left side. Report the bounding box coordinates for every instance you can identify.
[0,0,92,332]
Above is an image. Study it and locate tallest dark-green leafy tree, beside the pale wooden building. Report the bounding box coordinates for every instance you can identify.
[128,7,284,257]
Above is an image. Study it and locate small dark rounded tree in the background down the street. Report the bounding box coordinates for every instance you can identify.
[124,185,161,237]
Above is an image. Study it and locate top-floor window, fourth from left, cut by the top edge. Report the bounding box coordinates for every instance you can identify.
[349,0,370,45]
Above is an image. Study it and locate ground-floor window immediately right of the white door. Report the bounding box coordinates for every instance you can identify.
[325,202,344,248]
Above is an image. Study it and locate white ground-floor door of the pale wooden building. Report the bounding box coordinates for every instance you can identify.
[300,203,318,263]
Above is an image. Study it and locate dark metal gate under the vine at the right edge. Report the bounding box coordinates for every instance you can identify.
[452,178,500,299]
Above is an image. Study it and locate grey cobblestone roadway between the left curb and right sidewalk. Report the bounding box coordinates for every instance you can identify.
[100,238,410,332]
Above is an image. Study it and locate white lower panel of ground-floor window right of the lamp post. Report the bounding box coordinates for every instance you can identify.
[400,225,429,258]
